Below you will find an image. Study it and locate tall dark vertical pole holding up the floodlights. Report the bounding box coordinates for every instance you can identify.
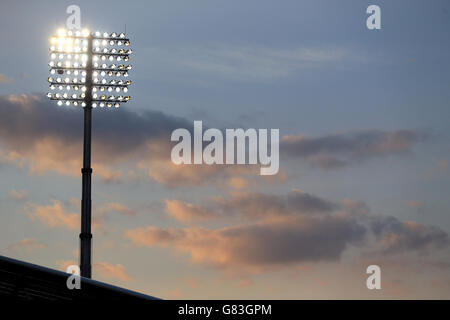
[80,35,93,278]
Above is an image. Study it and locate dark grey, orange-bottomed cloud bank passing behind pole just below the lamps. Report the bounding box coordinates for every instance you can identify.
[0,95,278,187]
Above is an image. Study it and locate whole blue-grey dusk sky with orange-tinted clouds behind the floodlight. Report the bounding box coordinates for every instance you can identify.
[0,0,450,299]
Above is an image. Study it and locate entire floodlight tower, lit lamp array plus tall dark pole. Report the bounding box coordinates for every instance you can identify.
[47,29,132,278]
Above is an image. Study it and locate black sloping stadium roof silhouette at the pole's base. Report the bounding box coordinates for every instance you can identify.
[0,256,158,301]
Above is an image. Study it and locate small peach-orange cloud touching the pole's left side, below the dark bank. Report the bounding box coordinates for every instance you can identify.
[26,200,80,230]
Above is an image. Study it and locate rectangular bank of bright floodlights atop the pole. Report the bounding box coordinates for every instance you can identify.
[47,29,132,108]
